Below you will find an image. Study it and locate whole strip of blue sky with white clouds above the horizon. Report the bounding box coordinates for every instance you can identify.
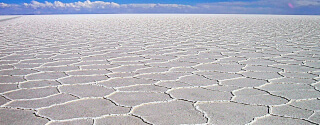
[0,0,320,15]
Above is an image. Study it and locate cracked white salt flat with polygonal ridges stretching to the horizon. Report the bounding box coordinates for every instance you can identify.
[0,15,320,125]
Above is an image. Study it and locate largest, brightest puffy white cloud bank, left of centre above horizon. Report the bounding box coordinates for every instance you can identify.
[19,0,195,13]
